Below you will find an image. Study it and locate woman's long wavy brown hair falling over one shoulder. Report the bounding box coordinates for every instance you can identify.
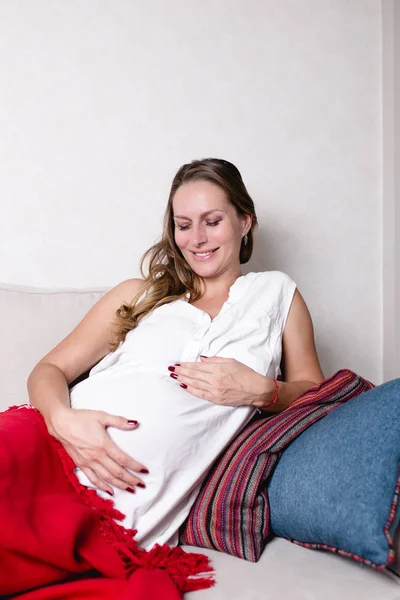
[111,158,257,351]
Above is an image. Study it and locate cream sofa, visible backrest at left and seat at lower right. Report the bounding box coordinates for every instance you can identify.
[0,284,400,600]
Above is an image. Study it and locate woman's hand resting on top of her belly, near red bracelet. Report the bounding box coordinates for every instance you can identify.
[168,356,275,407]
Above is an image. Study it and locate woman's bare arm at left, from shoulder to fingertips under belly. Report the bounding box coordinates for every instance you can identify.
[28,279,145,493]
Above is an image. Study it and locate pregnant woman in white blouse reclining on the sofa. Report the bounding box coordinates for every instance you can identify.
[3,159,323,596]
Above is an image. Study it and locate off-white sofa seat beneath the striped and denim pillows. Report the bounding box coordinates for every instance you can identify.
[182,538,400,600]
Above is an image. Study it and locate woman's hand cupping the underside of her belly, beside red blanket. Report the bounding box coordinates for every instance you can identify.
[49,407,148,495]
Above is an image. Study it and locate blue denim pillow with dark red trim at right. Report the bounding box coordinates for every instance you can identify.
[268,379,400,569]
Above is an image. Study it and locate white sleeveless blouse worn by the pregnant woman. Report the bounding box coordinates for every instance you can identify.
[70,271,296,549]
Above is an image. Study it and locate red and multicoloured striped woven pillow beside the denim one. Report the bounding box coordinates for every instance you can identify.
[180,369,373,562]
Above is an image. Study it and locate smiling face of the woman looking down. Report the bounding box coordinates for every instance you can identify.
[172,181,251,277]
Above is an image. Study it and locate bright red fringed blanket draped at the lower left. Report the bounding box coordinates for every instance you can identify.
[0,406,213,600]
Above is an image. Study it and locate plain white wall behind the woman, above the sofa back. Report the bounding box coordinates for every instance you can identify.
[0,0,382,382]
